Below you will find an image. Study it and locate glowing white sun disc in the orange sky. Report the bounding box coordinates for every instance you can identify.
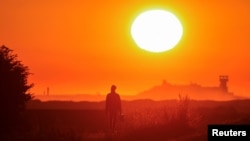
[131,10,183,52]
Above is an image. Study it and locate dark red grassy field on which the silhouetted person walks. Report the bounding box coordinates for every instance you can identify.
[7,97,250,141]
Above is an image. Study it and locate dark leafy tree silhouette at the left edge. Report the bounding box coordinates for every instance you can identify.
[0,45,33,137]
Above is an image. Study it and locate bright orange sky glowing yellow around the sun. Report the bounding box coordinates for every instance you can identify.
[0,0,250,96]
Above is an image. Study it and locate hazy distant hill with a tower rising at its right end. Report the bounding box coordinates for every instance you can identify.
[138,75,238,100]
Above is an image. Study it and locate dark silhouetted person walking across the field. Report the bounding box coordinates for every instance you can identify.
[106,85,121,132]
